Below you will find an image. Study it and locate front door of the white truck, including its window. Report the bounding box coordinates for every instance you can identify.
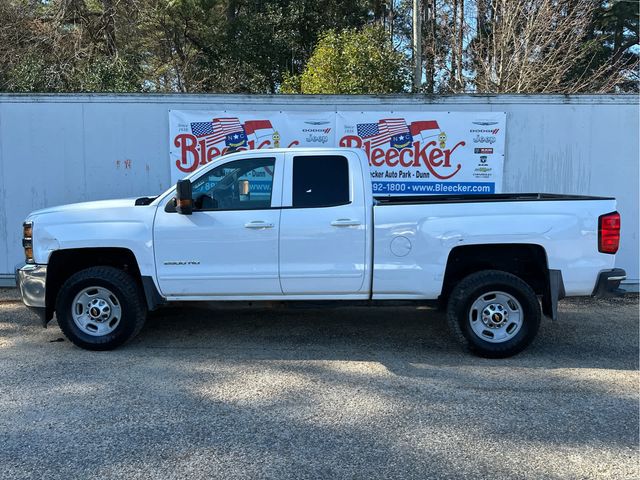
[154,153,284,299]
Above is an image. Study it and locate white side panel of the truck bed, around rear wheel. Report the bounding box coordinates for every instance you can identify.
[373,200,624,299]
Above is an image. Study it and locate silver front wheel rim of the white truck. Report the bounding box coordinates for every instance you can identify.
[71,287,122,337]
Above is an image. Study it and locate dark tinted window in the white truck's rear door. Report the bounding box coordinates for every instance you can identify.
[293,155,349,208]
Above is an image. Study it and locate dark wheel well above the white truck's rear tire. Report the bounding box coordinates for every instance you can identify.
[440,243,549,302]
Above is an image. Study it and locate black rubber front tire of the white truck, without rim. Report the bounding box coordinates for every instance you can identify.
[56,267,147,350]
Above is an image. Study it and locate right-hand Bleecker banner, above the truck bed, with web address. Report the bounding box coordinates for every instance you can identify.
[336,111,506,195]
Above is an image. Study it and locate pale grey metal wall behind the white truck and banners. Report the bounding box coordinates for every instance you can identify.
[0,94,640,281]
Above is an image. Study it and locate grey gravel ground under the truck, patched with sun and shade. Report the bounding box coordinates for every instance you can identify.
[0,290,640,480]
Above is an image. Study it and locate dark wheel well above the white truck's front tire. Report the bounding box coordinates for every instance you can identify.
[45,248,142,320]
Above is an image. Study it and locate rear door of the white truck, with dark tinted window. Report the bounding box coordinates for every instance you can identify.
[279,153,368,296]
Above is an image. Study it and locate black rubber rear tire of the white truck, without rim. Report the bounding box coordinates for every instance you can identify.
[447,270,541,358]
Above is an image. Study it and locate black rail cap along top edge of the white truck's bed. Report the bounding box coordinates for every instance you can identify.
[374,193,614,206]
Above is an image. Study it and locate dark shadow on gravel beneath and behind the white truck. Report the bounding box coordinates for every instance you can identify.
[141,295,639,376]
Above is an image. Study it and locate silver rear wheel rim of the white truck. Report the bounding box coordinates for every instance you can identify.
[469,291,524,343]
